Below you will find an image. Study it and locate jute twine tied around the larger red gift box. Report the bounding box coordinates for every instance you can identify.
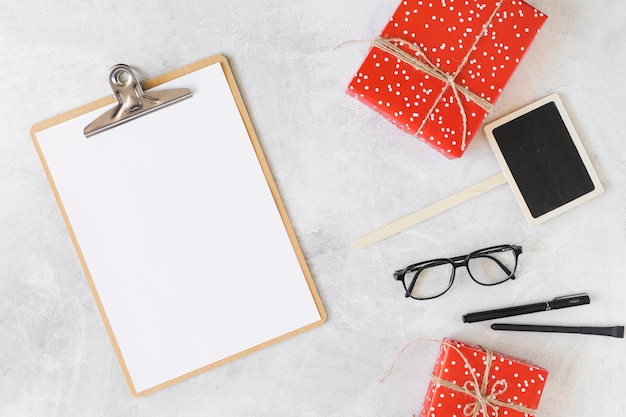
[348,0,504,151]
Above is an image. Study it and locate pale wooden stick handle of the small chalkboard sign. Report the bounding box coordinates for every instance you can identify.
[352,172,506,249]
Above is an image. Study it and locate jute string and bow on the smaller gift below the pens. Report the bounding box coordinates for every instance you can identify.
[380,339,537,417]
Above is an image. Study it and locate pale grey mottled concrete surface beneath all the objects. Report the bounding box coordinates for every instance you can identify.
[0,0,626,417]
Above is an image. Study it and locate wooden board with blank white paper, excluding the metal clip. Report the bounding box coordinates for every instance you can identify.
[31,55,326,396]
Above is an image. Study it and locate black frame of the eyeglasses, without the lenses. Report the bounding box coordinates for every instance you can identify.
[393,245,522,300]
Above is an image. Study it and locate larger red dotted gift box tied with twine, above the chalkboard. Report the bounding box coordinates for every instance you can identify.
[348,0,547,158]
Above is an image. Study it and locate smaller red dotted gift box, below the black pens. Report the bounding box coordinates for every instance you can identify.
[420,339,548,417]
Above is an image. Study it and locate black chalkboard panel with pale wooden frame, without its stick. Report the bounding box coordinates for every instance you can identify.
[485,94,603,224]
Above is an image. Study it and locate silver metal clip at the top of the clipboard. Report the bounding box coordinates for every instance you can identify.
[83,64,191,137]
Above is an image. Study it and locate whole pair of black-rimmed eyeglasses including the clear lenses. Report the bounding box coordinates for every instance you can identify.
[393,245,522,300]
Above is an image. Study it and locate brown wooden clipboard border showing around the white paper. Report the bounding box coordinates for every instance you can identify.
[30,55,327,397]
